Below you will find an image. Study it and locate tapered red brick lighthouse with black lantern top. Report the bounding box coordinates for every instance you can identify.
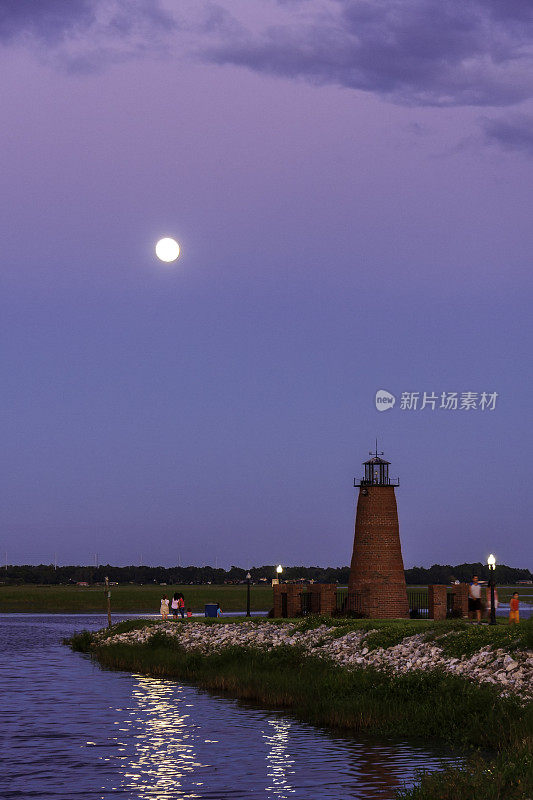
[348,443,409,618]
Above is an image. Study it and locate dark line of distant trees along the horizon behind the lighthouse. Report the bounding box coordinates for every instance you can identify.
[0,562,533,585]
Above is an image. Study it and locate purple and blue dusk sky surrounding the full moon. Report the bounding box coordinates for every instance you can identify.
[0,0,533,567]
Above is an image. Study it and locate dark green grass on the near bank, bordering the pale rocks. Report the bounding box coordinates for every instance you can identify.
[69,619,533,800]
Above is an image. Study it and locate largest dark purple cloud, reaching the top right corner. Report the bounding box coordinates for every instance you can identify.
[207,0,533,106]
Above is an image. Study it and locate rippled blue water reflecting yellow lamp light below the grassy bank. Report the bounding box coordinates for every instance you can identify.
[0,614,460,800]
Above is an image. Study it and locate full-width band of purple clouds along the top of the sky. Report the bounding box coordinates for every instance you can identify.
[6,0,533,106]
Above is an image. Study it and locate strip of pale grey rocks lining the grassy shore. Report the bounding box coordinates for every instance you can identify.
[94,621,533,701]
